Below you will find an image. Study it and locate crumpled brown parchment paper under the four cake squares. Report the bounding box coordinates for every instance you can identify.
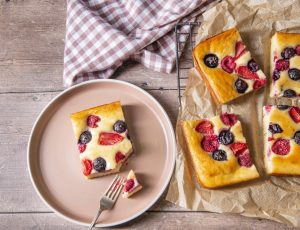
[166,0,300,227]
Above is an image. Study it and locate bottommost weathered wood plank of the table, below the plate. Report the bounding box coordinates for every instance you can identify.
[0,212,293,230]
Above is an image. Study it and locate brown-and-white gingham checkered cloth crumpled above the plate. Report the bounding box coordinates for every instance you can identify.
[64,0,209,87]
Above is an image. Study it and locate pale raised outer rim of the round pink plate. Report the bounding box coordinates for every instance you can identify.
[27,79,177,227]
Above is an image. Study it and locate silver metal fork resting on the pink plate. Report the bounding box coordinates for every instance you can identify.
[89,175,124,230]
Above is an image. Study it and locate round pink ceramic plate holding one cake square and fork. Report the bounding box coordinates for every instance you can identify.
[28,80,176,227]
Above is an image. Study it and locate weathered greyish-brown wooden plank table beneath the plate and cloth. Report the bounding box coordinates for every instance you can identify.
[0,0,294,229]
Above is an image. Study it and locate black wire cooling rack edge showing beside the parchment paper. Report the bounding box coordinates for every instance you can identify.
[175,22,200,106]
